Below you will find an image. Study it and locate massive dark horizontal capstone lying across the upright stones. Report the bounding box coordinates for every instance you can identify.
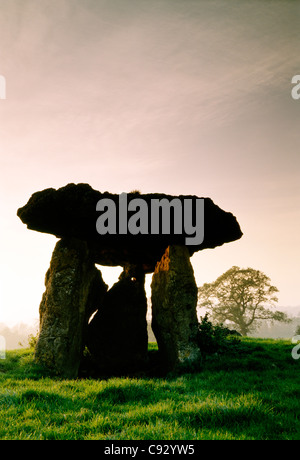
[18,184,242,273]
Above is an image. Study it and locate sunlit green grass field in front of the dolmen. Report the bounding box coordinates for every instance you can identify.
[0,338,300,440]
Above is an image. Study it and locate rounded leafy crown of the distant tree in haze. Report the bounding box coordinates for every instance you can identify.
[198,266,290,335]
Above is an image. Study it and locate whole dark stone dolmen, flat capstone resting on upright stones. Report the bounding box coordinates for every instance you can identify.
[17,184,242,378]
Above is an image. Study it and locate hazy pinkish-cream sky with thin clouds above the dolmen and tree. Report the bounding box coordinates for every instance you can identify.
[0,0,300,322]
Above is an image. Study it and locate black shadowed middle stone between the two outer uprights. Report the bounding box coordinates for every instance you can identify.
[87,266,148,374]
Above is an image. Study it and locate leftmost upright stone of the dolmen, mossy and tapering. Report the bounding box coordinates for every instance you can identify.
[36,238,107,378]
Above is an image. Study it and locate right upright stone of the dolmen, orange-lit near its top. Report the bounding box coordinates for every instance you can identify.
[151,246,200,370]
